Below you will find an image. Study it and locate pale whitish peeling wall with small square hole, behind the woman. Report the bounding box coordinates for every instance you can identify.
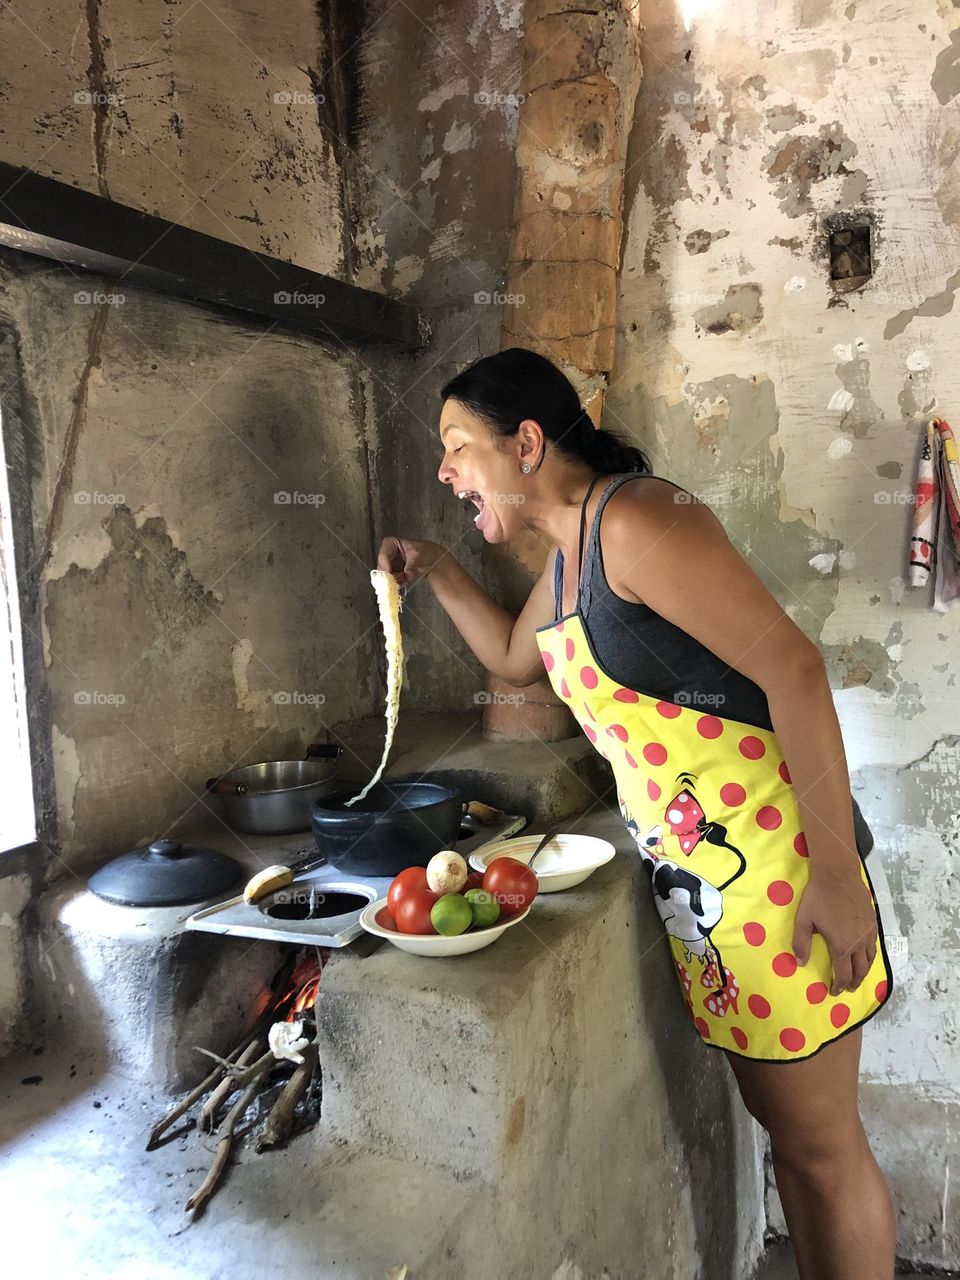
[604,0,960,1266]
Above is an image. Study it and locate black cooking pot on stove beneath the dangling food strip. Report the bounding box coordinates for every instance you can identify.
[311,778,461,876]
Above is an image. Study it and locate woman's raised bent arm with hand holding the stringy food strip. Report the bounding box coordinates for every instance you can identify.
[378,538,557,685]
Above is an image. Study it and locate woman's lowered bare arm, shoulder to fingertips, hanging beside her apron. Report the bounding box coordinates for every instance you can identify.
[603,480,877,995]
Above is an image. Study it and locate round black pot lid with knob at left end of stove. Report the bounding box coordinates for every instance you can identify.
[87,840,243,906]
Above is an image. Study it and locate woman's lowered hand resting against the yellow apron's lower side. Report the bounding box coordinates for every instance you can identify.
[794,855,877,996]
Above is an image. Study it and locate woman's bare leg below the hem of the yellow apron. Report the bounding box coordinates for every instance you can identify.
[727,1028,896,1280]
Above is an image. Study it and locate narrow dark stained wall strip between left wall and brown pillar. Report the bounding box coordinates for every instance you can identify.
[356,0,524,710]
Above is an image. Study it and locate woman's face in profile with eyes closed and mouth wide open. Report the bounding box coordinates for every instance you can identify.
[438,398,529,543]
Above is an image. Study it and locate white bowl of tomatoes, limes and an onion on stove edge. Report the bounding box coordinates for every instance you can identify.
[360,850,538,956]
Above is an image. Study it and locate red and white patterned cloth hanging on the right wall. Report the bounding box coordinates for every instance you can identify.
[908,417,960,613]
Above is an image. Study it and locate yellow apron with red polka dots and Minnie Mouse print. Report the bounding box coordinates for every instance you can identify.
[536,481,892,1062]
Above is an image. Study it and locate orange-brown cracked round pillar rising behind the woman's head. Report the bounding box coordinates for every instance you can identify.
[483,0,641,741]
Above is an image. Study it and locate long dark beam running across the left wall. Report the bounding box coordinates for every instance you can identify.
[0,161,429,348]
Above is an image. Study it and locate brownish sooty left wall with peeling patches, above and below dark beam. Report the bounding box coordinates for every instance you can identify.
[0,0,399,890]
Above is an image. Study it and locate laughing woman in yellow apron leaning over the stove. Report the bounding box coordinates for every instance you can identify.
[379,348,895,1280]
